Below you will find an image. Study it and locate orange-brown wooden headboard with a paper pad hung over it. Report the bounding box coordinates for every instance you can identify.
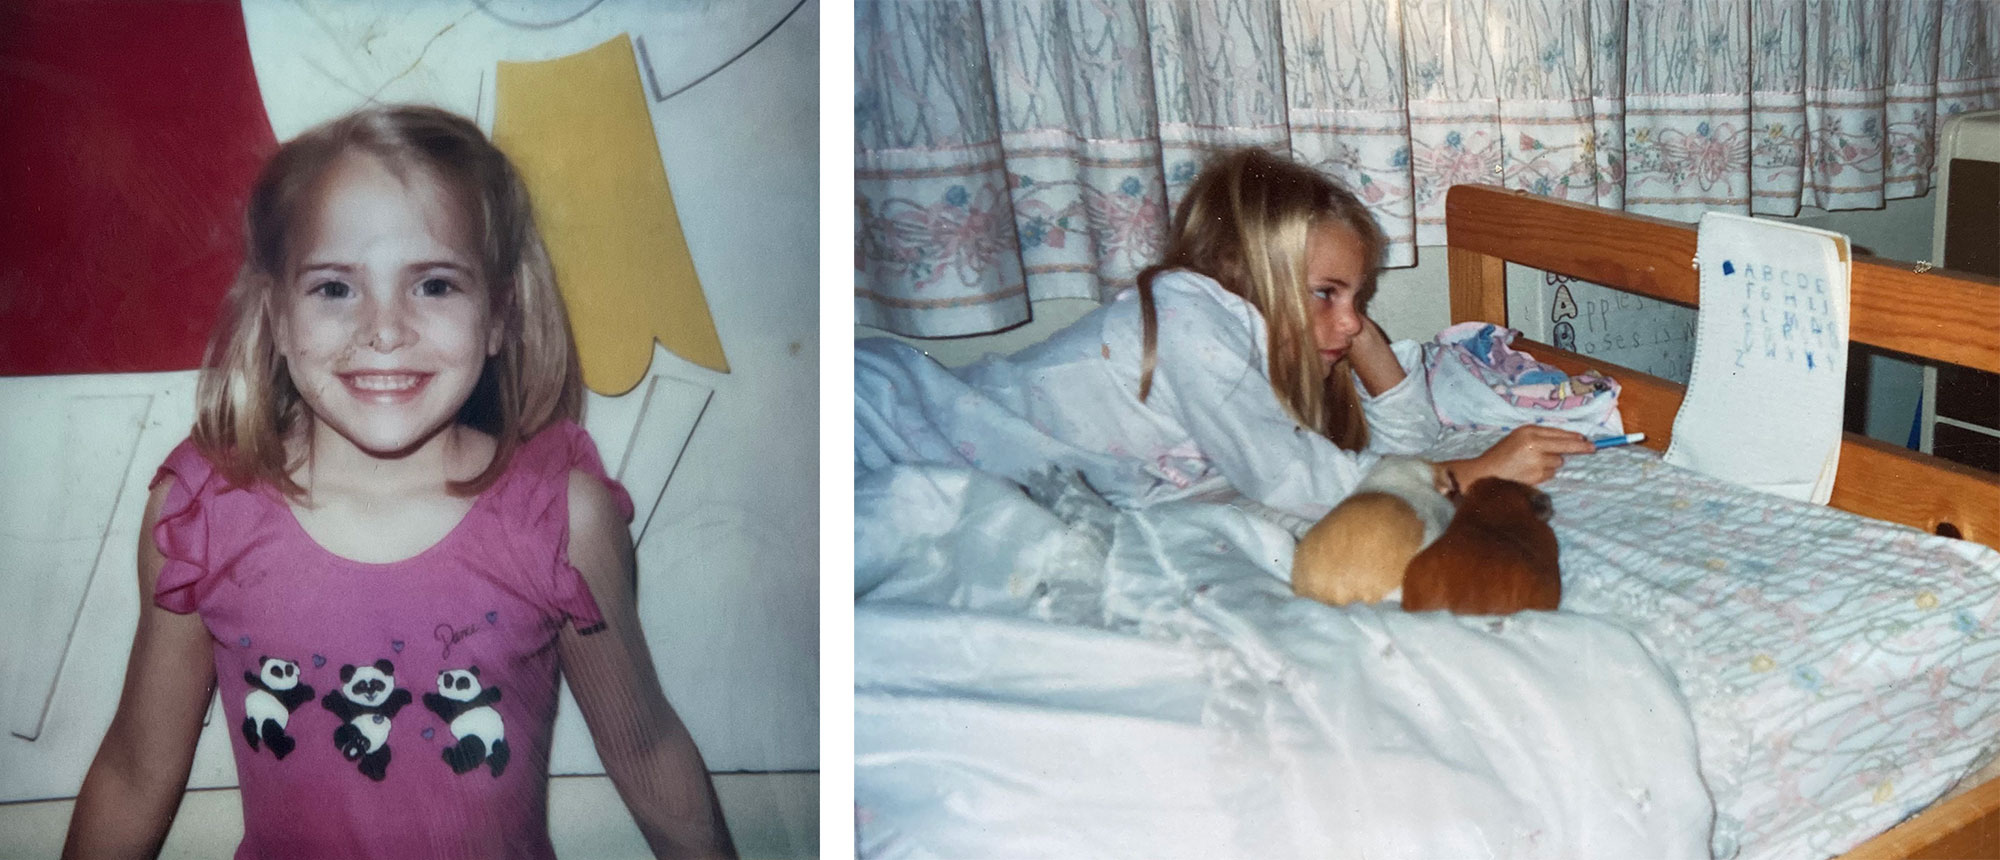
[1444,186,2000,548]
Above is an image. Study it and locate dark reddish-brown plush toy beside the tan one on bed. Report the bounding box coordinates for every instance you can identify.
[1402,478,1562,616]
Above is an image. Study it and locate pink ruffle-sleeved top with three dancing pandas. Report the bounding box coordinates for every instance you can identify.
[154,422,632,860]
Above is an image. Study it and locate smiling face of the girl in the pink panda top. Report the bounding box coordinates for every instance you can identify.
[272,154,500,464]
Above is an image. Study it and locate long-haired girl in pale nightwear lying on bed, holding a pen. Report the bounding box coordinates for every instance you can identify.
[854,148,1592,520]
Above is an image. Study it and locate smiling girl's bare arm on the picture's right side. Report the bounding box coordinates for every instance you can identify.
[558,472,736,858]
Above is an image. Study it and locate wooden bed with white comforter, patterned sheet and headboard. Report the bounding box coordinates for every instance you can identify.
[856,186,2000,860]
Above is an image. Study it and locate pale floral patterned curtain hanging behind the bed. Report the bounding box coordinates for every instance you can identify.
[854,0,2000,336]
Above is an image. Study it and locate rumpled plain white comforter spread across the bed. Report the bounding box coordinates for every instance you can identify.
[854,466,1714,858]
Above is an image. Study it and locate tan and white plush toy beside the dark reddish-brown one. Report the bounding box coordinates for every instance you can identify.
[1292,456,1452,606]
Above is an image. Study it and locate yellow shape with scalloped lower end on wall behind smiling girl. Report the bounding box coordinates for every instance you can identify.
[494,34,730,394]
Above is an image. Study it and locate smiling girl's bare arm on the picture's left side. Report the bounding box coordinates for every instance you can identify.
[62,482,216,858]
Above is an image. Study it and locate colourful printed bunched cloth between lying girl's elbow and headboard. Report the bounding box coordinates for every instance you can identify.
[1424,322,1624,436]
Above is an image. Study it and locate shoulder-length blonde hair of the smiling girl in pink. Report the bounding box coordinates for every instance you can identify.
[194,106,584,496]
